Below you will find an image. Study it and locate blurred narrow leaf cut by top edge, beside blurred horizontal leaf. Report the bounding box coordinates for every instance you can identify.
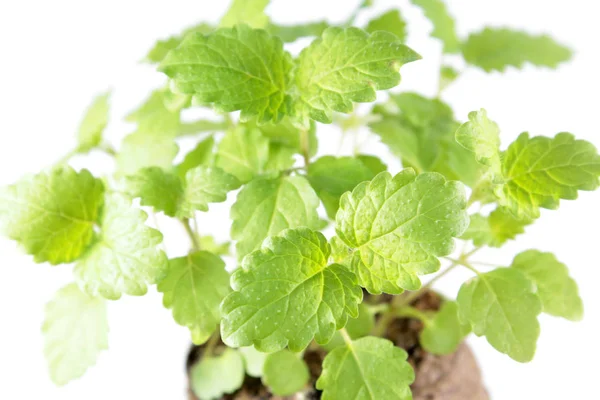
[411,0,460,53]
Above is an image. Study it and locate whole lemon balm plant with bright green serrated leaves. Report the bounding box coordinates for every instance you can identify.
[0,0,600,400]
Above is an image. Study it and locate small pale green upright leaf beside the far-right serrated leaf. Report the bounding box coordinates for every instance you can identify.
[456,108,502,182]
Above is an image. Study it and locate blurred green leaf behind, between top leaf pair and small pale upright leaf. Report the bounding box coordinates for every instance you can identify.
[369,93,480,186]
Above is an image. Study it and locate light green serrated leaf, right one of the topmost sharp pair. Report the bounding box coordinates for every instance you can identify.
[295,28,420,125]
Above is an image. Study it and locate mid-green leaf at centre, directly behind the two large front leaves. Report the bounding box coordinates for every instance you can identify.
[231,176,319,260]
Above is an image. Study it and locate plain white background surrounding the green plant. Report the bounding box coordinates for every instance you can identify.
[0,0,600,400]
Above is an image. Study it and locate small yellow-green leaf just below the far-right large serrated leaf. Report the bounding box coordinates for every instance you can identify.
[462,207,531,247]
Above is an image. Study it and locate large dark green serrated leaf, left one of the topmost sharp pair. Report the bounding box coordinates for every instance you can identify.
[159,25,292,122]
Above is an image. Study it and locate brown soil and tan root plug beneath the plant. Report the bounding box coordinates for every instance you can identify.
[187,292,489,400]
